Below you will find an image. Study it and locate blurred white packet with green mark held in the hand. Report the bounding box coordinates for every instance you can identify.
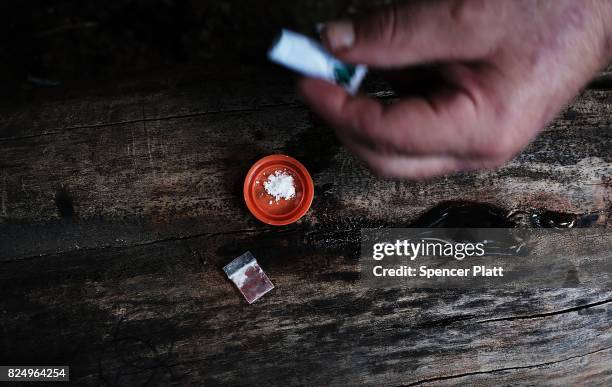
[268,29,368,94]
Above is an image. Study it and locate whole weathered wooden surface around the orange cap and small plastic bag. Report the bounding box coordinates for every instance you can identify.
[0,69,612,386]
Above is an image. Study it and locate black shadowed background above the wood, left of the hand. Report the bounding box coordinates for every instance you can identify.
[0,0,382,104]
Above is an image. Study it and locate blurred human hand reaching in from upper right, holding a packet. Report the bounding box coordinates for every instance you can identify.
[299,0,612,179]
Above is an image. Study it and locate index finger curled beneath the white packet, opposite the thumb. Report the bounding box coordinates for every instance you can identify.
[299,79,491,158]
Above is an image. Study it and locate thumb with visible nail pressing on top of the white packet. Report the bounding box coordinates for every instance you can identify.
[321,1,499,67]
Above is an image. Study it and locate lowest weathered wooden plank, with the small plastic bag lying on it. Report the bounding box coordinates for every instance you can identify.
[0,231,612,385]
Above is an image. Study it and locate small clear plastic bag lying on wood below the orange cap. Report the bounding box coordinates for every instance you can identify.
[223,251,274,304]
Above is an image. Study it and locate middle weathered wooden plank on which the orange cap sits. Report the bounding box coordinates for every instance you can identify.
[0,76,612,258]
